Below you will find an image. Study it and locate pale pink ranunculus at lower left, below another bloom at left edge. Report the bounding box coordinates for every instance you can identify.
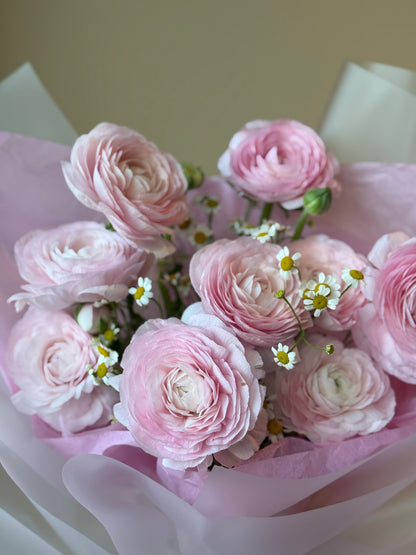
[6,307,117,435]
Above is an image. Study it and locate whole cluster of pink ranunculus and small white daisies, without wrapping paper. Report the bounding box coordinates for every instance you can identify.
[7,120,416,471]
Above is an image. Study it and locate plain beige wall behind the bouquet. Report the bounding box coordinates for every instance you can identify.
[0,0,416,172]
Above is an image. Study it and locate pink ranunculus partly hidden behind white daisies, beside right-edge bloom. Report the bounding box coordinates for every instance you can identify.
[291,235,367,331]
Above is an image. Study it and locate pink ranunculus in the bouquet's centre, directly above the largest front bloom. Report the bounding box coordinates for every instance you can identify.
[190,237,312,347]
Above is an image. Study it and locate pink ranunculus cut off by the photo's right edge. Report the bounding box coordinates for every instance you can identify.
[353,232,416,384]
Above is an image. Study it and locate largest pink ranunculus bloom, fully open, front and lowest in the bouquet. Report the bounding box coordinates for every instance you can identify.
[114,305,264,469]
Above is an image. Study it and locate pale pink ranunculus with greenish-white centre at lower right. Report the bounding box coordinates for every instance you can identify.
[274,335,396,443]
